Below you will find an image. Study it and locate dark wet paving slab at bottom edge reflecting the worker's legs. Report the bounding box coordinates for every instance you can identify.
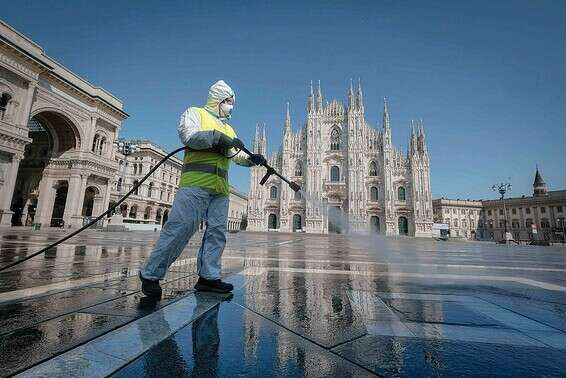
[113,303,374,377]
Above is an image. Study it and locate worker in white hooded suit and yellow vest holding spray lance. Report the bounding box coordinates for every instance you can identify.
[139,80,266,298]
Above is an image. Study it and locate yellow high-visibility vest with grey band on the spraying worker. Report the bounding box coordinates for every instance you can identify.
[179,108,236,195]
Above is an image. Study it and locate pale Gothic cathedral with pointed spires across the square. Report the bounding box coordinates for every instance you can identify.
[248,82,433,236]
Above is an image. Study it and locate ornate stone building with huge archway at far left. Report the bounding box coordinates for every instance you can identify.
[0,21,128,227]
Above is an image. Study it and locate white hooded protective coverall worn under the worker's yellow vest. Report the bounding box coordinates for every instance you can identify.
[141,80,252,280]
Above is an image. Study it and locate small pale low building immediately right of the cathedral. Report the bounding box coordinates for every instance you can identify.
[432,198,482,239]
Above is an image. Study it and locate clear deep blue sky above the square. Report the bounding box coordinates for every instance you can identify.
[1,0,566,198]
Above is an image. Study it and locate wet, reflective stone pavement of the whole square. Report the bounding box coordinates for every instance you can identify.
[0,230,566,377]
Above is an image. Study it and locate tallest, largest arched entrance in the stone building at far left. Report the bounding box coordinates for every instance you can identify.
[10,111,80,226]
